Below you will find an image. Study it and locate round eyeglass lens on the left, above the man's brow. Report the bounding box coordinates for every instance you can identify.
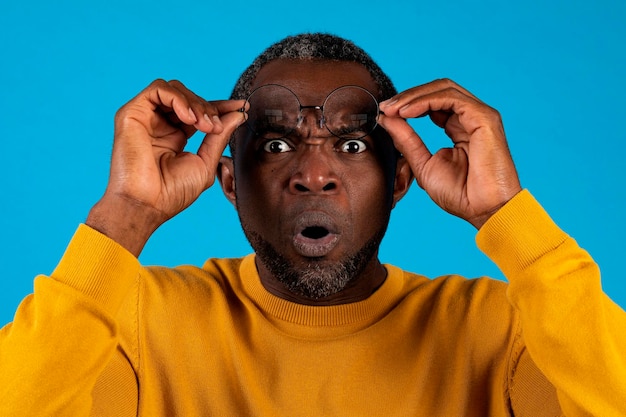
[246,84,300,139]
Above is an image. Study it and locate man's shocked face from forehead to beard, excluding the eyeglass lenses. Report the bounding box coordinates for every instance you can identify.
[227,60,402,299]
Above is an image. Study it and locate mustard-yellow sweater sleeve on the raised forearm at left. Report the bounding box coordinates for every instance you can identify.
[0,225,140,417]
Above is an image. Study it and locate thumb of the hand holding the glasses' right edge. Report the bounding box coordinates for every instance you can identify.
[379,115,432,186]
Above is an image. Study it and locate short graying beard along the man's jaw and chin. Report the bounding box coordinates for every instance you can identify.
[244,227,385,300]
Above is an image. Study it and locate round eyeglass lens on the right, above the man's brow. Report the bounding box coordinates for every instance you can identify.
[322,85,378,139]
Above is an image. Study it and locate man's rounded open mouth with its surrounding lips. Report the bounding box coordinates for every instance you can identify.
[293,212,339,258]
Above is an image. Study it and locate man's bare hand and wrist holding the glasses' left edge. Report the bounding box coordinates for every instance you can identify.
[85,80,245,256]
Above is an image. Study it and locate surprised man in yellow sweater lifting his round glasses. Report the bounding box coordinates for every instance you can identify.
[0,34,626,416]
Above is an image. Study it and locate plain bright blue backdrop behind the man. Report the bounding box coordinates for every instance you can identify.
[0,0,626,325]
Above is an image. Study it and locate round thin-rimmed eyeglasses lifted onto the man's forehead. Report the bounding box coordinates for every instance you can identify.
[241,84,379,139]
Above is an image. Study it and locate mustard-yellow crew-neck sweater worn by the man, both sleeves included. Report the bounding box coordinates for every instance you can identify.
[0,191,626,417]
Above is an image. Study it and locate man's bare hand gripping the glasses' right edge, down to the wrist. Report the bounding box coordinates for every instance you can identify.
[379,79,521,229]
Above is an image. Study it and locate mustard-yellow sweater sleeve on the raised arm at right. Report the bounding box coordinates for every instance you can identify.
[477,190,626,417]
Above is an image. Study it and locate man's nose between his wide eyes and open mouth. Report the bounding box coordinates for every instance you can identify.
[289,146,340,195]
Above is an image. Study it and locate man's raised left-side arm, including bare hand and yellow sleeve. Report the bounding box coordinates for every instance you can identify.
[0,80,244,417]
